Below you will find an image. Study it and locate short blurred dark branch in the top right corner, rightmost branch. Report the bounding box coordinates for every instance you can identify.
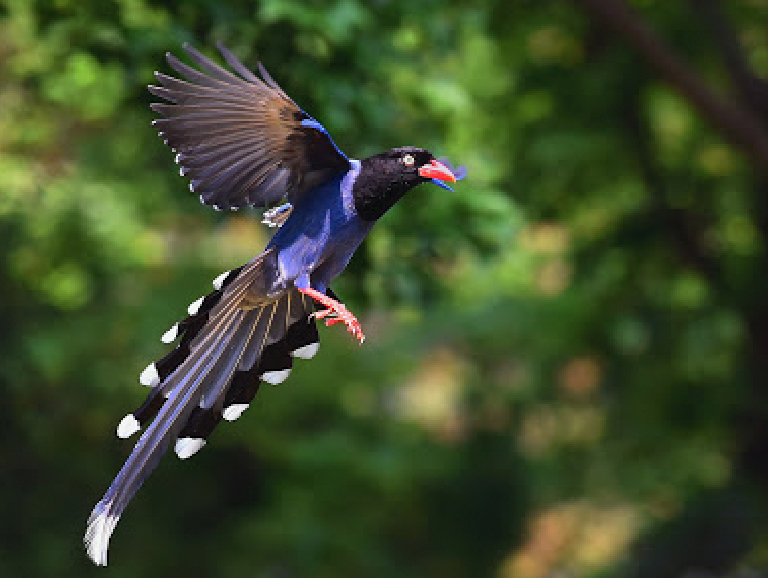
[690,0,768,122]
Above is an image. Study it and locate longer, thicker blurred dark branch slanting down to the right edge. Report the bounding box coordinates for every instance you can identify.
[572,0,768,167]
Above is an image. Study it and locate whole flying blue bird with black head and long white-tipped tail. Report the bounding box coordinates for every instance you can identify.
[83,43,466,566]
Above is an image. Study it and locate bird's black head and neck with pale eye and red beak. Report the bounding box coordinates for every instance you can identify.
[352,147,456,221]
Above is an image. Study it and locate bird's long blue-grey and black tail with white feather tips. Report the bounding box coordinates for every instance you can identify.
[84,251,318,566]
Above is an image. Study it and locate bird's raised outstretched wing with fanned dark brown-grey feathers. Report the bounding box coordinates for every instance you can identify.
[149,44,350,209]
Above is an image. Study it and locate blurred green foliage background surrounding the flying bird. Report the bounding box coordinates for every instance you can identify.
[0,0,768,578]
